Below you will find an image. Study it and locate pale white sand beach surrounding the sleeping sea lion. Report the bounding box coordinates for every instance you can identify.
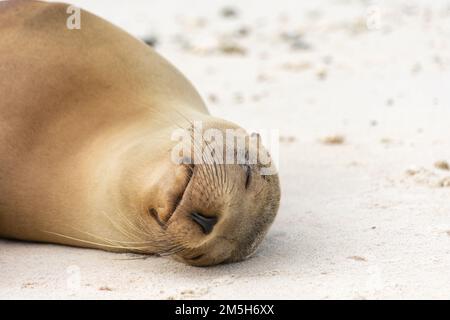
[0,0,450,299]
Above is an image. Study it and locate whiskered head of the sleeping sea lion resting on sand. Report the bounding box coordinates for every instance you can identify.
[144,123,280,266]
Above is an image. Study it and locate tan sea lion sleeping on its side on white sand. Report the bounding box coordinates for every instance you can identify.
[0,1,280,266]
